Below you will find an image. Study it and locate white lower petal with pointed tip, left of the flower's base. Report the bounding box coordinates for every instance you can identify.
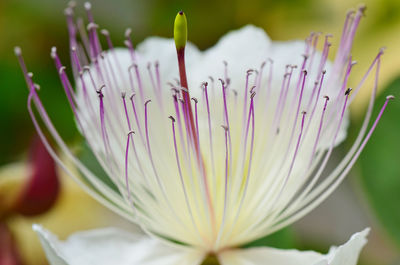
[33,225,203,265]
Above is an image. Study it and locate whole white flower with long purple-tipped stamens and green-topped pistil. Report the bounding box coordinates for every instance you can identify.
[16,4,392,265]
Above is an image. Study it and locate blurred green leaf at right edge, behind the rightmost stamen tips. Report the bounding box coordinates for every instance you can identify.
[359,78,400,246]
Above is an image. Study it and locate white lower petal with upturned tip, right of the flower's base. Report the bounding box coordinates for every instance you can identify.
[219,228,369,265]
